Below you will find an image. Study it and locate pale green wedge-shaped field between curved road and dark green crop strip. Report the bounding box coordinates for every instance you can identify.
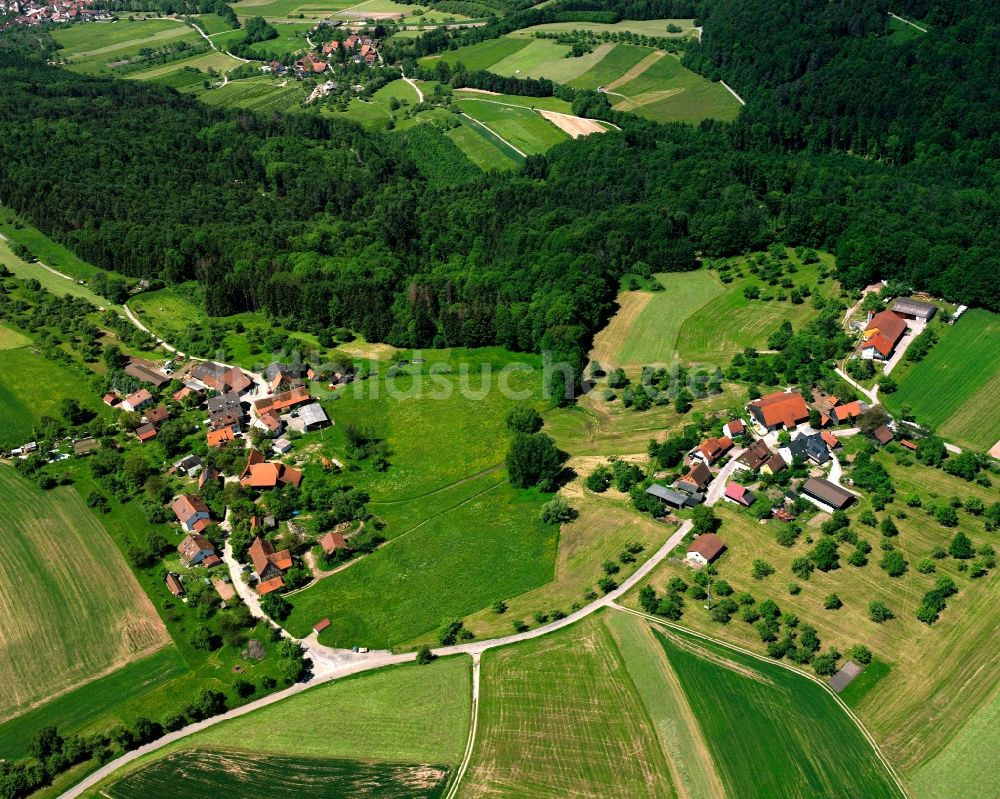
[95,657,472,796]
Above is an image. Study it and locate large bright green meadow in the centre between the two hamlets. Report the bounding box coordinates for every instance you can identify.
[289,350,557,646]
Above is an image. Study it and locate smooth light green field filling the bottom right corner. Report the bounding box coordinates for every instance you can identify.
[909,694,1000,799]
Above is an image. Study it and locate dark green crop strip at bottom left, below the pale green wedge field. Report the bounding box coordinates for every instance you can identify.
[101,749,448,799]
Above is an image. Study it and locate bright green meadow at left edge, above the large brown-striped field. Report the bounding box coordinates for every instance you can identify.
[0,347,107,449]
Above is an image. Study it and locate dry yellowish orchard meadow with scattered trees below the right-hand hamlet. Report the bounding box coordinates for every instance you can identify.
[628,453,1000,772]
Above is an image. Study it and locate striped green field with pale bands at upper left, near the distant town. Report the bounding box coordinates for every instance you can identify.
[52,19,204,75]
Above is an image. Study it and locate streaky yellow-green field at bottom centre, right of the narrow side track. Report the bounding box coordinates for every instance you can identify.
[459,617,676,799]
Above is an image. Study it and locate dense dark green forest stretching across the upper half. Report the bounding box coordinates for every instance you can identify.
[0,0,1000,388]
